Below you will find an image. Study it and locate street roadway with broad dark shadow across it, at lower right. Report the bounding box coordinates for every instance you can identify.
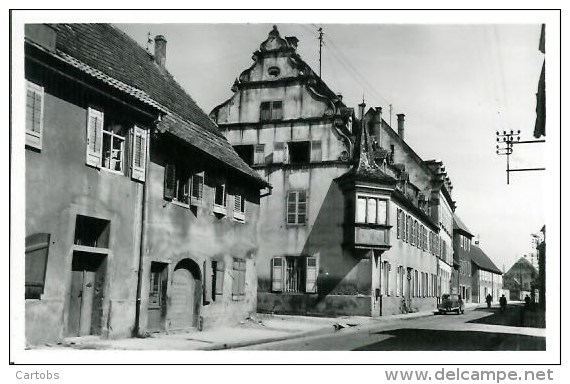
[234,305,546,351]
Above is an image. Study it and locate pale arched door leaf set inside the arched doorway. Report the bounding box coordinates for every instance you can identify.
[170,268,195,329]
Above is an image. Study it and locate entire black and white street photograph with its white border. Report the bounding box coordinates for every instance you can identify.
[6,6,564,372]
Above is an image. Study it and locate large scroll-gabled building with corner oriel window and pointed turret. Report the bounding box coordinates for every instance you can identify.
[210,27,455,316]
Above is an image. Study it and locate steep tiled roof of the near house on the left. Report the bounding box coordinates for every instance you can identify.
[44,24,268,185]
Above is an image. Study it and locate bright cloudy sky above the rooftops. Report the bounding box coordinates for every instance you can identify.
[116,23,548,271]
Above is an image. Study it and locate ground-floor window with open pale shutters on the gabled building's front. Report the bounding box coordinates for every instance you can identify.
[271,256,318,293]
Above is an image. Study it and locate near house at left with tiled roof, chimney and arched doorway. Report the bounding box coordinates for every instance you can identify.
[22,24,268,344]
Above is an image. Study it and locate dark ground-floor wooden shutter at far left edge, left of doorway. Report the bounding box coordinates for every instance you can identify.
[25,233,50,299]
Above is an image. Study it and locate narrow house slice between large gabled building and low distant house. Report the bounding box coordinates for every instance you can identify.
[451,214,473,303]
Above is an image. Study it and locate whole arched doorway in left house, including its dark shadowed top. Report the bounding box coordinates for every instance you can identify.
[169,259,202,329]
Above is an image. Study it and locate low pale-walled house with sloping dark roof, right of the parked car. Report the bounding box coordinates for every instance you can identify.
[469,244,503,303]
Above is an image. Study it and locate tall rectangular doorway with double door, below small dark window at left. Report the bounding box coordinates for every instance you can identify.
[66,251,107,337]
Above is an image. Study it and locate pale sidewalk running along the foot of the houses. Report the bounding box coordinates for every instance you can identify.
[43,311,433,350]
